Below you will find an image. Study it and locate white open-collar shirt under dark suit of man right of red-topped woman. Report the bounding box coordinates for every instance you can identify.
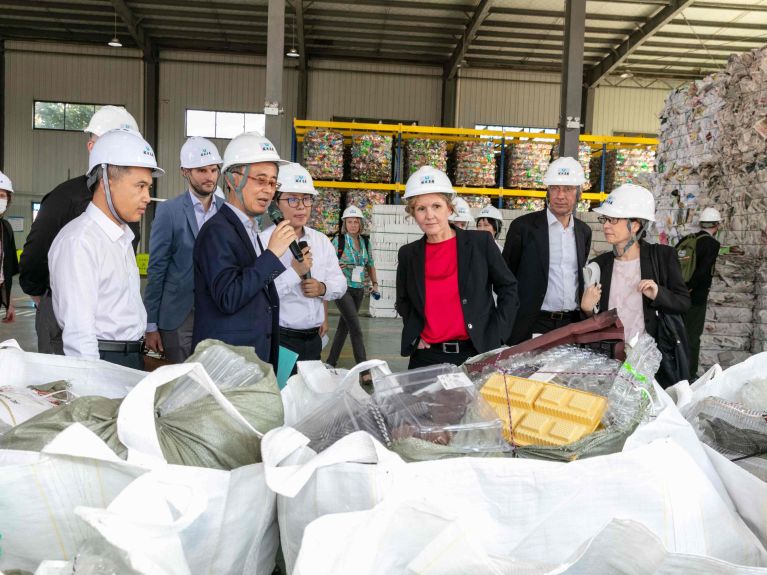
[541,208,579,311]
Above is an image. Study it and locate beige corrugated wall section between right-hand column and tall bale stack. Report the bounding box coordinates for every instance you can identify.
[592,86,670,135]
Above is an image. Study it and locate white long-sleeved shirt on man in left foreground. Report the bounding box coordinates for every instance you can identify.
[48,203,146,359]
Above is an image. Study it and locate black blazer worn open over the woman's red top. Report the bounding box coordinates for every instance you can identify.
[395,228,519,355]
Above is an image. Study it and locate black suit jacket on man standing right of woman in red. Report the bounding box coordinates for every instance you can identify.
[503,209,591,345]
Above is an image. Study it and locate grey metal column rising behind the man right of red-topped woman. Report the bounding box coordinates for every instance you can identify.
[559,0,586,158]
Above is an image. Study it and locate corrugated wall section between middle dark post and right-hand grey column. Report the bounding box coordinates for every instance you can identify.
[456,69,560,128]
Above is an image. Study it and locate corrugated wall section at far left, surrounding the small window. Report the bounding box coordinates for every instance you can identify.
[4,40,144,247]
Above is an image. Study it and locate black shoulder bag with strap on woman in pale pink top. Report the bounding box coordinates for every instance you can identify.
[648,245,690,389]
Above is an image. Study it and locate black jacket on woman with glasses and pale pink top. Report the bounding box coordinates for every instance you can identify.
[593,241,690,338]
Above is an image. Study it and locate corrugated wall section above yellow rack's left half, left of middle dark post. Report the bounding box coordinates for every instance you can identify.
[307,61,442,126]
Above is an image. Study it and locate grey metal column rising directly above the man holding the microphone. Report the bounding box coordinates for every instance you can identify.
[264,0,285,154]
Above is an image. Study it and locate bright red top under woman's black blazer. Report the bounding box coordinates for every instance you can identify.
[421,238,469,343]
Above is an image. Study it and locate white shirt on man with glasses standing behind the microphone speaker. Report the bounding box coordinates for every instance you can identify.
[259,226,346,329]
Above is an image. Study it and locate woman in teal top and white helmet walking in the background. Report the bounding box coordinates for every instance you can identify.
[327,206,378,383]
